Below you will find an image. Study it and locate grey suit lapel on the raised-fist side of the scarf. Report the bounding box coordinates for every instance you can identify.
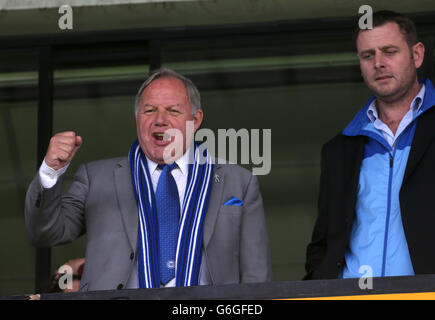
[114,159,138,252]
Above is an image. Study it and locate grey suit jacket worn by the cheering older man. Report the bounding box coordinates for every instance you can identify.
[25,158,272,291]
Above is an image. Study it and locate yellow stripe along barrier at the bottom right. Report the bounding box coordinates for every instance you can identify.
[283,292,435,300]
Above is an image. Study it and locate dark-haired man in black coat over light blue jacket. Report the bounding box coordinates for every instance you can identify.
[305,11,435,279]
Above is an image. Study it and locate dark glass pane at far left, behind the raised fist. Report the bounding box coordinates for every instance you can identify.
[0,50,38,295]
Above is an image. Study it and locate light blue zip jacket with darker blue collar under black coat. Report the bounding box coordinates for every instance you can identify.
[341,79,435,278]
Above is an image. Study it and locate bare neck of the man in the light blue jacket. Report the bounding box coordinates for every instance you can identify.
[376,81,421,134]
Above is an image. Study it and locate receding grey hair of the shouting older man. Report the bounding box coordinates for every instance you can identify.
[134,68,201,115]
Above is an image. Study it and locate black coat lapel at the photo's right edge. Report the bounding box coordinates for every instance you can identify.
[402,107,435,185]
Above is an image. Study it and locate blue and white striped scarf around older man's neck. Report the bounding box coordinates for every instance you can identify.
[129,140,213,288]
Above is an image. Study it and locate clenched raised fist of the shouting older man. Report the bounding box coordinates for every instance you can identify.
[45,131,83,170]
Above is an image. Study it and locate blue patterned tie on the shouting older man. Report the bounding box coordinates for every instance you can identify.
[156,162,180,284]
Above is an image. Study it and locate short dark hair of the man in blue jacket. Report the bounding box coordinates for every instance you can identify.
[354,10,418,48]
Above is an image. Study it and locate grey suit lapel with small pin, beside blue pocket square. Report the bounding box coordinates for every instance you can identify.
[203,164,225,248]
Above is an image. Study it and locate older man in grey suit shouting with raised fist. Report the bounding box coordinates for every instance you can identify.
[25,69,271,291]
